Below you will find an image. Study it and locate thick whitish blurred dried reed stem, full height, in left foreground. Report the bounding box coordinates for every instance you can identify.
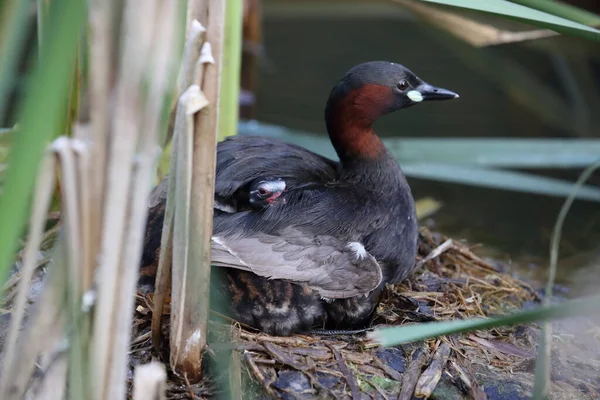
[92,0,176,399]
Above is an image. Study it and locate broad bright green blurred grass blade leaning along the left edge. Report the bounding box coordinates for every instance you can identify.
[0,0,85,279]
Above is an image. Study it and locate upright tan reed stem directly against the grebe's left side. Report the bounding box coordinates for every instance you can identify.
[184,0,225,380]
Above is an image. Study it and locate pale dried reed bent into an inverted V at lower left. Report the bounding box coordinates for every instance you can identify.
[5,137,93,398]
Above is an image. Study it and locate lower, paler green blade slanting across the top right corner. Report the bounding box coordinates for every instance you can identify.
[414,0,600,40]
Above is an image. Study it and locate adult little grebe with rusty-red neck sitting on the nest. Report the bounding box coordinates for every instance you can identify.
[142,61,458,335]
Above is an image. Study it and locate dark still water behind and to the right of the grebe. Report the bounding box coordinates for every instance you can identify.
[250,9,600,288]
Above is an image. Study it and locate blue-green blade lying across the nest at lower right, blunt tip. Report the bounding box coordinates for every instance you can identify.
[369,296,600,347]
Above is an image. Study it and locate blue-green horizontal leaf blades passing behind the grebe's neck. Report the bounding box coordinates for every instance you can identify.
[238,121,600,201]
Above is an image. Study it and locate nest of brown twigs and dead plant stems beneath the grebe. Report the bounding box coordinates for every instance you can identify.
[131,230,600,399]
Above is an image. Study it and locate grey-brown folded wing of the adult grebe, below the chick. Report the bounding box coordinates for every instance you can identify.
[212,228,382,299]
